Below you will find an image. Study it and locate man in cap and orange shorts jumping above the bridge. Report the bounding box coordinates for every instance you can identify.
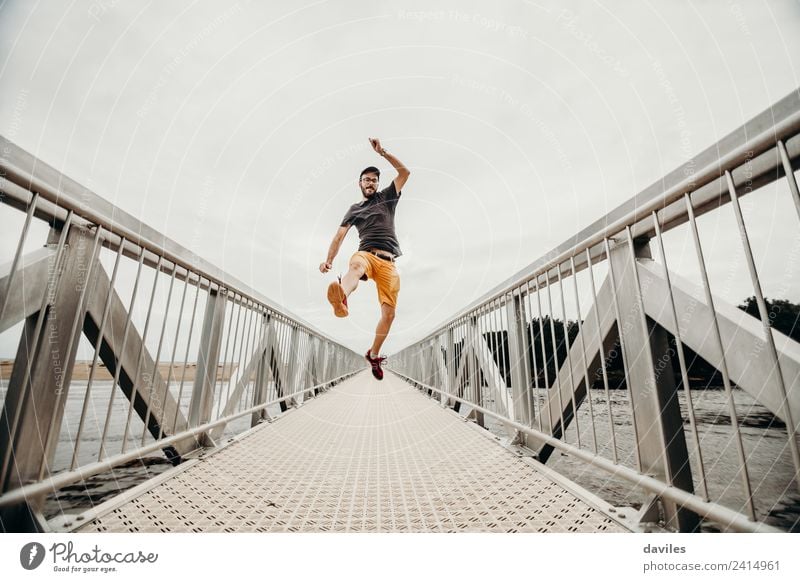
[319,138,411,380]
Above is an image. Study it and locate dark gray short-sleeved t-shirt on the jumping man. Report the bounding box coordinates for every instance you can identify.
[341,182,403,257]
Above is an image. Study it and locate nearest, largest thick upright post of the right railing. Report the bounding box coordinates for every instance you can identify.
[609,241,699,531]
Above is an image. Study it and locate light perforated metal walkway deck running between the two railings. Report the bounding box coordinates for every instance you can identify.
[79,371,626,532]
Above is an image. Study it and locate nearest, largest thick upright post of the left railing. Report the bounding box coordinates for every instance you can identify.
[0,226,100,532]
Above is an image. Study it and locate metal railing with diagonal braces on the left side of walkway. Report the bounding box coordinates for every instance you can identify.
[0,138,364,531]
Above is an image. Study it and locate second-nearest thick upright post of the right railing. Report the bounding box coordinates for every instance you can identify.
[506,293,533,438]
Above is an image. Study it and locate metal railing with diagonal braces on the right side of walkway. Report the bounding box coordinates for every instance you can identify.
[390,92,800,531]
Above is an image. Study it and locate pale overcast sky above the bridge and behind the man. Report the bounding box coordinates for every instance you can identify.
[0,0,800,353]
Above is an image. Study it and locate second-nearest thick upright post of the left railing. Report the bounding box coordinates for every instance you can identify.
[188,289,228,442]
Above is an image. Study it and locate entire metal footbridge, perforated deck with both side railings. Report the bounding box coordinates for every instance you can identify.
[0,92,800,532]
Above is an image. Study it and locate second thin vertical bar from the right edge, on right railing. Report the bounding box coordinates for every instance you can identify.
[725,170,800,491]
